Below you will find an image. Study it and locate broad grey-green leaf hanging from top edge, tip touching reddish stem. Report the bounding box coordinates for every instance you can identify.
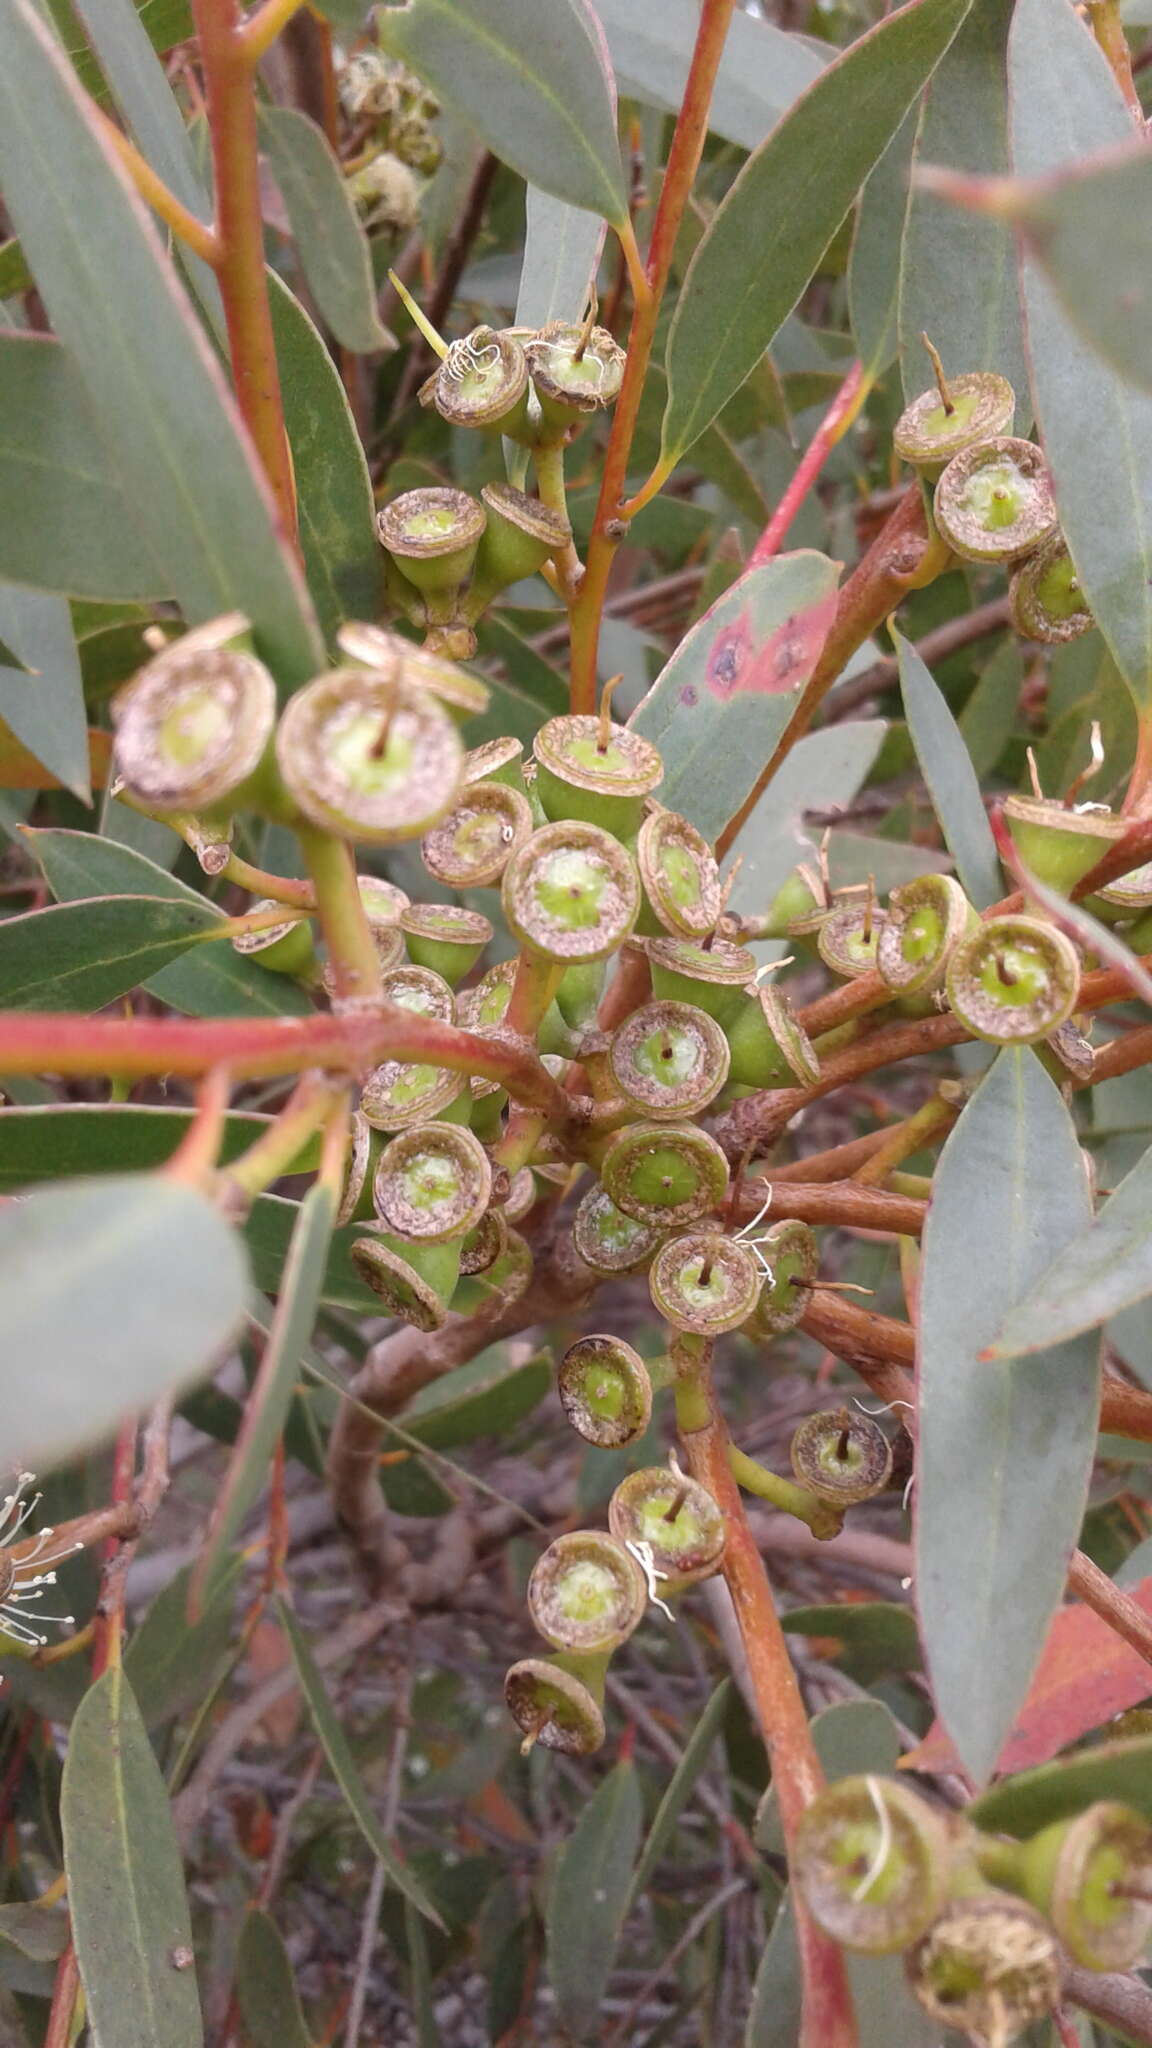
[377,0,627,225]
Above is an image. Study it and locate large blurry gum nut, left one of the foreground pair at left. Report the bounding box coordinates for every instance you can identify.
[113,612,280,821]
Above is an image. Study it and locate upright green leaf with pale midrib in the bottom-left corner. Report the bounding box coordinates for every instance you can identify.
[59,1665,203,2048]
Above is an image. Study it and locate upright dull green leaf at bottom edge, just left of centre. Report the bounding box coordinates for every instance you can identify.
[547,1759,644,2042]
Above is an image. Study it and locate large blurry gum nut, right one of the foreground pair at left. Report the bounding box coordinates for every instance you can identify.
[277,668,463,846]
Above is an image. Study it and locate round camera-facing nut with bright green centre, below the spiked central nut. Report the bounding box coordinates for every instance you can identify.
[500,819,640,963]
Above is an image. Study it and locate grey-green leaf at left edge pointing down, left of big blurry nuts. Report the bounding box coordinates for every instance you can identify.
[0,584,90,803]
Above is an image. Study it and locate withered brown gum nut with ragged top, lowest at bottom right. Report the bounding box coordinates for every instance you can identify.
[904,1890,1064,2048]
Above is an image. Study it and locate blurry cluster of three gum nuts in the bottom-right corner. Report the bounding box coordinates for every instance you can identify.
[793,1776,1152,2048]
